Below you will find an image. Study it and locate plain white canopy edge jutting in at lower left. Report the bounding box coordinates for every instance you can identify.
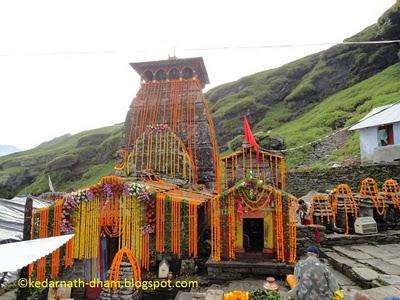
[0,234,74,272]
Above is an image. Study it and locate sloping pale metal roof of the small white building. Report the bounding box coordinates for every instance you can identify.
[349,103,400,130]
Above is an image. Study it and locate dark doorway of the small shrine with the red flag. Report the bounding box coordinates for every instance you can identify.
[243,218,264,252]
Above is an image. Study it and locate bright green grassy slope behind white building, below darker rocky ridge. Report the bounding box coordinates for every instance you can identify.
[271,63,400,167]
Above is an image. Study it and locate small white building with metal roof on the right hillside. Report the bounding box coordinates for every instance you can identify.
[349,103,400,164]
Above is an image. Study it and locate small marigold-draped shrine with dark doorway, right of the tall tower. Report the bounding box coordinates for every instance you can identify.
[211,144,297,263]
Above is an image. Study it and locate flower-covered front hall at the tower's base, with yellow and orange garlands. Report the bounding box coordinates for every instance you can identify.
[29,176,205,280]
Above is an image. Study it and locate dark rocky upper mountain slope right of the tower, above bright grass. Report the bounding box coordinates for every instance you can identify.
[207,0,400,151]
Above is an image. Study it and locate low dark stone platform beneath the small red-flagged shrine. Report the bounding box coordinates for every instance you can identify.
[206,259,294,281]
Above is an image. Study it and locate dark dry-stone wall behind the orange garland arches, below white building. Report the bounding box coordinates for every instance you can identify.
[286,164,400,197]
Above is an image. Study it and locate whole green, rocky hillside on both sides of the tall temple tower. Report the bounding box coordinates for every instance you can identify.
[0,0,400,197]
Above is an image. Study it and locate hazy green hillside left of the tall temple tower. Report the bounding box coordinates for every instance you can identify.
[0,124,123,197]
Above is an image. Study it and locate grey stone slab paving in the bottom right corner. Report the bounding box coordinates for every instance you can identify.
[321,244,400,300]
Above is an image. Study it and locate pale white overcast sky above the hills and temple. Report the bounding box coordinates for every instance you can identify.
[0,0,395,149]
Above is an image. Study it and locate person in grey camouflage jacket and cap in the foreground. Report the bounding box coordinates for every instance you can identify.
[288,246,344,300]
